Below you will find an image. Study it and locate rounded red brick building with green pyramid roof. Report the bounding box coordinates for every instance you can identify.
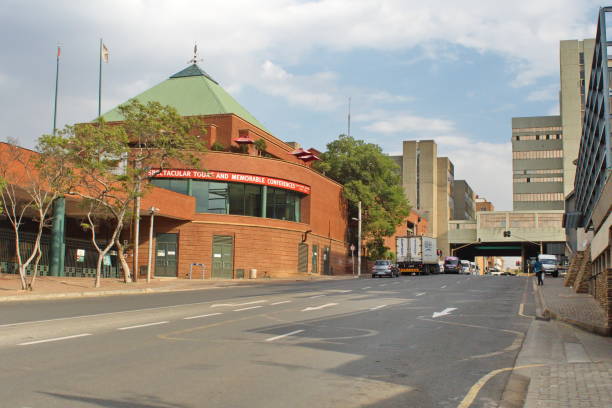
[0,64,351,278]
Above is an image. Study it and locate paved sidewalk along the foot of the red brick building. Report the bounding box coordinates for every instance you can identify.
[0,274,353,303]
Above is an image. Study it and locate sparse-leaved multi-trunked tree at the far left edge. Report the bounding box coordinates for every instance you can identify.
[0,136,72,290]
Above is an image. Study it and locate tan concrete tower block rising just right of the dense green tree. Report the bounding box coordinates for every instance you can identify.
[391,140,454,255]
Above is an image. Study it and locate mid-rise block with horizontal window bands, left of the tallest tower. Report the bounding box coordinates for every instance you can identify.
[512,116,565,211]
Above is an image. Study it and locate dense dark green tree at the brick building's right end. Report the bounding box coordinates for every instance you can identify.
[315,135,410,256]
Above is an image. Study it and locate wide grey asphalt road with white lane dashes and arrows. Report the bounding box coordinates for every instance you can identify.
[0,275,533,408]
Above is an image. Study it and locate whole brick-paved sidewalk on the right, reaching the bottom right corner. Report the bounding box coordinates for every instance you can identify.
[508,279,612,408]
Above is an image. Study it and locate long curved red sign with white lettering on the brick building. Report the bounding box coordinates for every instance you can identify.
[149,169,310,194]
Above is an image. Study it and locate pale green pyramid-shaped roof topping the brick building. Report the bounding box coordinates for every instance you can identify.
[102,64,268,132]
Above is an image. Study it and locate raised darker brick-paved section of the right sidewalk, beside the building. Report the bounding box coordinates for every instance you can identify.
[533,278,612,336]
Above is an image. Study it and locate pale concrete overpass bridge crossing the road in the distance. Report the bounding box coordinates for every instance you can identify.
[448,210,565,265]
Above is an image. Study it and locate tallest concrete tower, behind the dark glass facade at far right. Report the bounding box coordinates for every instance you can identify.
[559,39,595,196]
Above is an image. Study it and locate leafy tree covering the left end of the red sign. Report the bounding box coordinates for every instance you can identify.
[119,99,205,282]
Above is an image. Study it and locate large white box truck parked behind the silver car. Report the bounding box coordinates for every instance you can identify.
[395,236,440,275]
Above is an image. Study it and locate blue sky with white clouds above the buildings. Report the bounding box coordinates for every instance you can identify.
[0,0,599,209]
